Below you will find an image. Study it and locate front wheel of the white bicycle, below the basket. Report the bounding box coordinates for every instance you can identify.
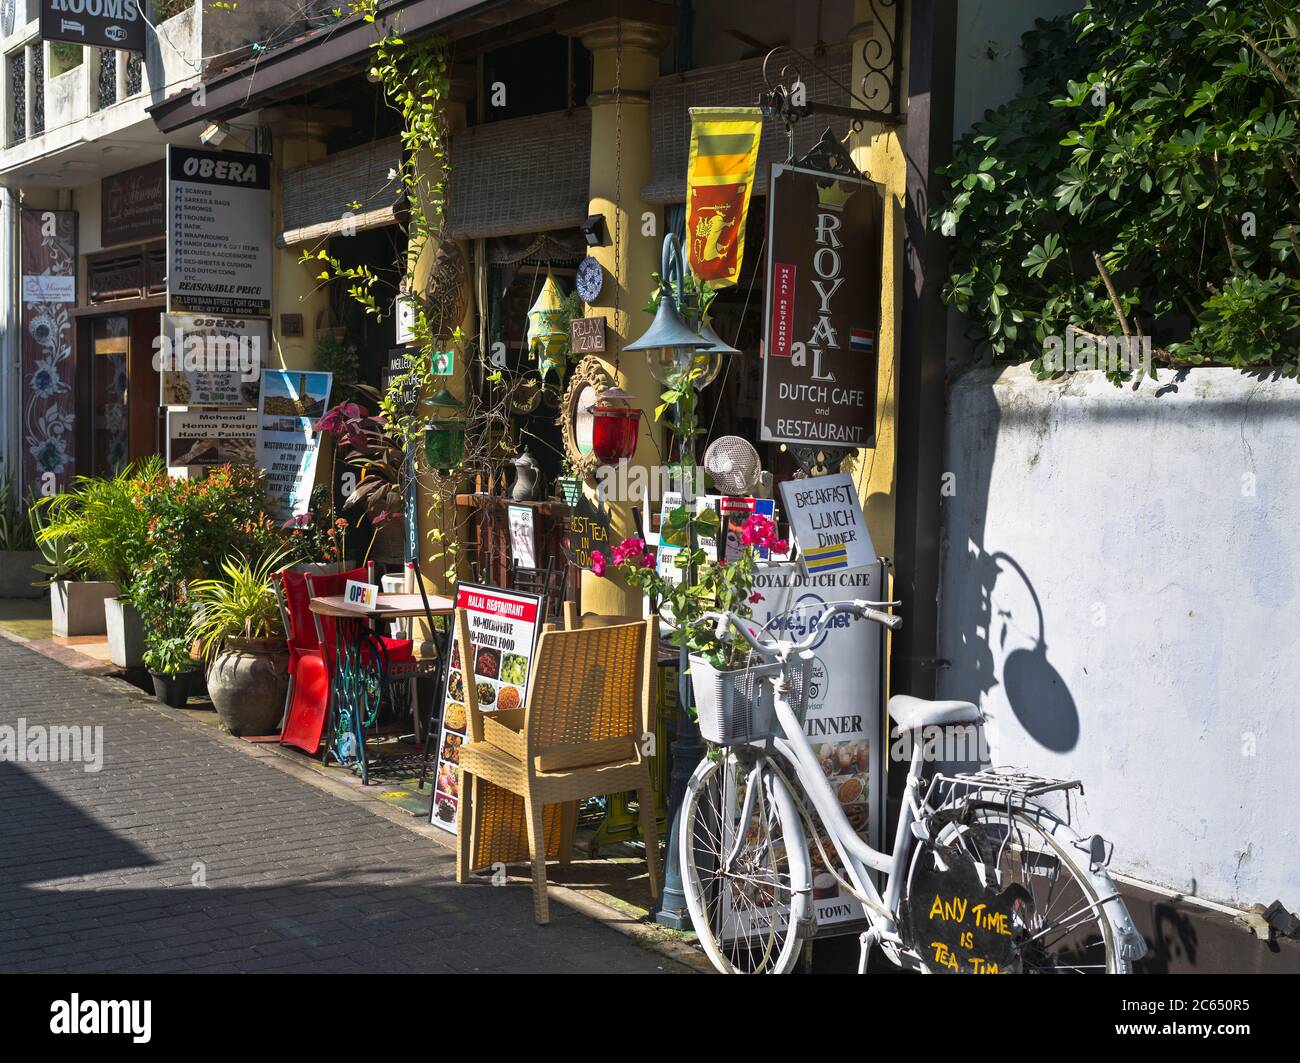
[679,752,810,975]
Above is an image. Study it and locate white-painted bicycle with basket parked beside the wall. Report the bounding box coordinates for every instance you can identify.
[679,600,1147,975]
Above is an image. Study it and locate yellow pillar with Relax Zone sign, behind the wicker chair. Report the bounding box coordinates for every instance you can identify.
[568,10,672,615]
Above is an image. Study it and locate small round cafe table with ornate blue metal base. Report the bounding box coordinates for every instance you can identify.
[308,594,452,786]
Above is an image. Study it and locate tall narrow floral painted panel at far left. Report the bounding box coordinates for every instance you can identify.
[22,211,77,494]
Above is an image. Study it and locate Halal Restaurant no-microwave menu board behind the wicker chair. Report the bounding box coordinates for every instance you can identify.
[429,583,546,833]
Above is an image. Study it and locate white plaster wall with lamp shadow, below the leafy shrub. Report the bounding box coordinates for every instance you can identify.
[940,368,1300,910]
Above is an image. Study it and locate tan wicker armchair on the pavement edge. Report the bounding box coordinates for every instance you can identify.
[455,609,659,923]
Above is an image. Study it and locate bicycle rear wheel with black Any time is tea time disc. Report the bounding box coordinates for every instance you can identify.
[907,803,1130,975]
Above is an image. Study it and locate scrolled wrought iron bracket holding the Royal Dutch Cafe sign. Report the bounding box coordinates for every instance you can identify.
[758,0,907,136]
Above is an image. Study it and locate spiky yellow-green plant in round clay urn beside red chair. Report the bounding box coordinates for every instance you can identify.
[189,548,293,736]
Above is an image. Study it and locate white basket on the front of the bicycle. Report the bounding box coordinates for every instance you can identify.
[690,647,809,746]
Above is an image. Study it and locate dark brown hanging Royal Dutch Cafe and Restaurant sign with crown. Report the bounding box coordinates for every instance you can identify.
[762,165,883,447]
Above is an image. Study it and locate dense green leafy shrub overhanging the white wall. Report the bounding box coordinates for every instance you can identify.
[932,0,1300,376]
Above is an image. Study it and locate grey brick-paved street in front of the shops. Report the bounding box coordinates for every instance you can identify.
[0,638,685,973]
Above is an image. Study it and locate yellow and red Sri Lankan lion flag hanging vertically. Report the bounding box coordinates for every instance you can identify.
[686,107,763,287]
